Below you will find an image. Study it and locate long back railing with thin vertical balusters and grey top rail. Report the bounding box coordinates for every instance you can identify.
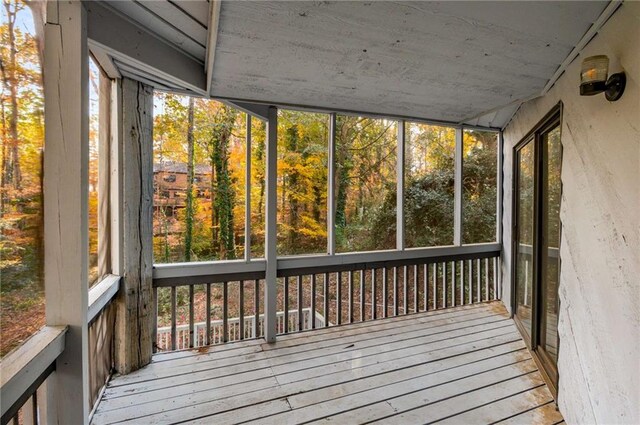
[154,244,500,351]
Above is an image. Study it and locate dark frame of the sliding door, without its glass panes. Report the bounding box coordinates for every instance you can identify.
[510,101,563,401]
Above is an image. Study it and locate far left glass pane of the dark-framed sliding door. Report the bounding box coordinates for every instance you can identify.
[515,142,535,337]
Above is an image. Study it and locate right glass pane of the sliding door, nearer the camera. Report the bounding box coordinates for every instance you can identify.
[541,127,562,363]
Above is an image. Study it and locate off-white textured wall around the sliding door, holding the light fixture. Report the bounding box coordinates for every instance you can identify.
[502,2,640,424]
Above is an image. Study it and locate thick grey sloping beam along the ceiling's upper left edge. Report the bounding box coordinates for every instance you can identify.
[84,2,208,96]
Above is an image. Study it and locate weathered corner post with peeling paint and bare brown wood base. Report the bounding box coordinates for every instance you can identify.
[115,78,155,374]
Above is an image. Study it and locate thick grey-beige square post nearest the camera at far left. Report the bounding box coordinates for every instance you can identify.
[44,1,89,424]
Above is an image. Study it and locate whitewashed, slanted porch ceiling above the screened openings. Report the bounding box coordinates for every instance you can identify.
[100,0,608,127]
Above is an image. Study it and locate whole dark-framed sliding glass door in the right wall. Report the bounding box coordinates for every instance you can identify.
[513,105,562,392]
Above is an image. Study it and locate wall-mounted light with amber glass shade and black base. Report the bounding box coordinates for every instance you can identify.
[580,55,627,102]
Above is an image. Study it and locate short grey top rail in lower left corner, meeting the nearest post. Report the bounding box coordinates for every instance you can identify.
[0,326,68,423]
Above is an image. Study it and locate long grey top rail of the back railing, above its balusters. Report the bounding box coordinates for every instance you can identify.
[153,243,500,287]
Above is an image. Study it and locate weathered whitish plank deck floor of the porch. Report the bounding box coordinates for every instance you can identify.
[92,302,562,425]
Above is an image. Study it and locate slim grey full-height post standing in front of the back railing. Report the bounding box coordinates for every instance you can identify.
[264,106,278,342]
